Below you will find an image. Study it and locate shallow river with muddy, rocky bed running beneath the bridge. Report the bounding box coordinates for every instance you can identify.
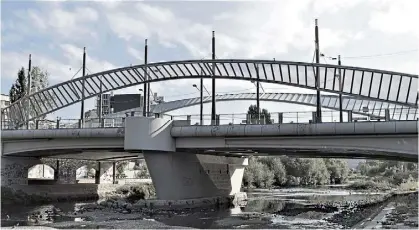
[1,188,417,229]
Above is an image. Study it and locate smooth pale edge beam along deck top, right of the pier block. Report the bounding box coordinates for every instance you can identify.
[171,121,418,137]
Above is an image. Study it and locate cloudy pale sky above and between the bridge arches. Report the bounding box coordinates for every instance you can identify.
[1,0,419,121]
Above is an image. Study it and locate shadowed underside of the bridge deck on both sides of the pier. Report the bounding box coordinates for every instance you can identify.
[3,147,418,162]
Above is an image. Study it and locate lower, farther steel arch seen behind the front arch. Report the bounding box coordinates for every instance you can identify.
[112,93,418,120]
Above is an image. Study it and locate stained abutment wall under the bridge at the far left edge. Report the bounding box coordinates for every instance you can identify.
[1,157,42,187]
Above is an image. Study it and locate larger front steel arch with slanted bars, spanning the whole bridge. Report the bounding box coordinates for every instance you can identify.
[2,59,418,124]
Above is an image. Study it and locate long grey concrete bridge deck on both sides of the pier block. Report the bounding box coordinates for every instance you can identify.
[2,121,418,161]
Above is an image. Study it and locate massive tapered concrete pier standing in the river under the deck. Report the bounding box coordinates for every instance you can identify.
[144,152,248,200]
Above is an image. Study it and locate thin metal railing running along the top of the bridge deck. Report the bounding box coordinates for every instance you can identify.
[1,109,417,130]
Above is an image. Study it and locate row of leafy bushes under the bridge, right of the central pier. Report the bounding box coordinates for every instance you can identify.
[243,156,349,188]
